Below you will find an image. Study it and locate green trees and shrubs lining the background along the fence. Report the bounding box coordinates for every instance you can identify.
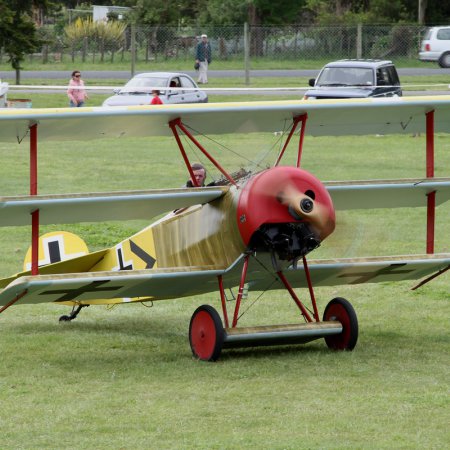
[0,0,450,84]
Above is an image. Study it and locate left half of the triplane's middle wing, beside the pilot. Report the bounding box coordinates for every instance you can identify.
[0,187,228,226]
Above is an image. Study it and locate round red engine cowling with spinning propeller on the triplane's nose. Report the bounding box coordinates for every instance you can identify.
[237,166,336,260]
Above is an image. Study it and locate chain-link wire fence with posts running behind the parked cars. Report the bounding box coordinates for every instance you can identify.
[0,24,424,64]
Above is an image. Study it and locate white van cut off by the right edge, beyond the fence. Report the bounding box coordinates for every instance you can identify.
[419,26,450,67]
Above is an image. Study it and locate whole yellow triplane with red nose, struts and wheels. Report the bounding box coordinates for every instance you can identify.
[0,96,450,361]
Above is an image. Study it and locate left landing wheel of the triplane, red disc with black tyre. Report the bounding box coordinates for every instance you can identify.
[189,305,225,361]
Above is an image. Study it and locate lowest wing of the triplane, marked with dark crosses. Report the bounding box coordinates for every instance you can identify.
[0,253,450,306]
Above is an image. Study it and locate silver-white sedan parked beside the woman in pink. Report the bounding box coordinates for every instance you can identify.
[103,72,208,106]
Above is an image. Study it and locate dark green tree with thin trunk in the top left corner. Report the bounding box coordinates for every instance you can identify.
[0,0,48,84]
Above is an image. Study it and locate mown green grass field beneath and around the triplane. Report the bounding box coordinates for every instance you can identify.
[0,97,450,449]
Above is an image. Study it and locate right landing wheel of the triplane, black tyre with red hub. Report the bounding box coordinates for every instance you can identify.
[323,297,358,350]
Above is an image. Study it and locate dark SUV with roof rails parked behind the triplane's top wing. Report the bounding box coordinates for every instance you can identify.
[303,59,402,100]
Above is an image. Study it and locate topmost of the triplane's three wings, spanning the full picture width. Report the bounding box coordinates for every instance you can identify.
[0,96,450,142]
